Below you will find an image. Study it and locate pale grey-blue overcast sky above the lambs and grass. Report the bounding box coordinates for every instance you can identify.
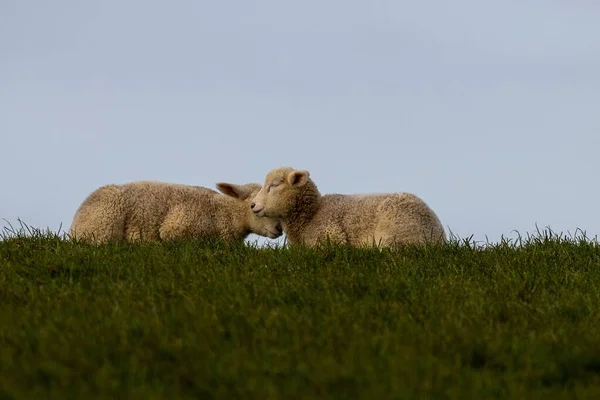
[0,0,600,242]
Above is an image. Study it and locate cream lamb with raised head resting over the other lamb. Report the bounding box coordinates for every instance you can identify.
[250,167,446,247]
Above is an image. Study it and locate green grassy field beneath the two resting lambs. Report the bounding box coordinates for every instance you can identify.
[0,227,600,399]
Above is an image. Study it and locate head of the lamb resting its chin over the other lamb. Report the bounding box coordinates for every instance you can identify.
[250,167,309,219]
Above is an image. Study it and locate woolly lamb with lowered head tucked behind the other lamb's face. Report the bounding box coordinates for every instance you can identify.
[69,181,283,243]
